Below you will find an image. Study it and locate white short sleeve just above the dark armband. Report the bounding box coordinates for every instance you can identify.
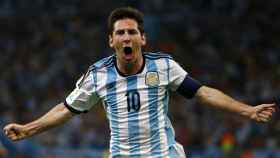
[168,59,188,91]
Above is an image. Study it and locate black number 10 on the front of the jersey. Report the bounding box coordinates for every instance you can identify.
[126,91,141,112]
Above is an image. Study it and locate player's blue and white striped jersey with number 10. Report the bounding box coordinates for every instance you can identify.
[66,53,187,158]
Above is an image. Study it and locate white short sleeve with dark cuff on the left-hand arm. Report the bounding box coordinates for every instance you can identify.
[65,71,100,113]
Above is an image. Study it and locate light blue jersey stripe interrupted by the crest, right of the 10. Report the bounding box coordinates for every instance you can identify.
[147,60,161,156]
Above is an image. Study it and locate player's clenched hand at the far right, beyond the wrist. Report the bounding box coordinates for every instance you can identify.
[249,104,276,122]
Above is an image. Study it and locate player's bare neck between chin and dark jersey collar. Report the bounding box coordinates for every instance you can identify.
[117,56,144,76]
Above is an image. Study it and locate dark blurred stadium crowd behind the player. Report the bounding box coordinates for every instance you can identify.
[0,0,280,158]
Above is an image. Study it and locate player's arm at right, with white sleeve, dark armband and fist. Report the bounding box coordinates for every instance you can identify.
[169,60,275,122]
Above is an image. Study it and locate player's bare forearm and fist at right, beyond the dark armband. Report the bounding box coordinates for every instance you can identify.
[195,86,275,122]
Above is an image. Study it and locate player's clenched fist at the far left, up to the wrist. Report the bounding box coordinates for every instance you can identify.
[4,123,30,141]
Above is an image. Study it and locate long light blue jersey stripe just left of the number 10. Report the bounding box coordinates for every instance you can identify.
[106,67,120,158]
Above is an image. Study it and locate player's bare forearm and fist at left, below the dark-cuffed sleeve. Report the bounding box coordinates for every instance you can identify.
[4,103,73,141]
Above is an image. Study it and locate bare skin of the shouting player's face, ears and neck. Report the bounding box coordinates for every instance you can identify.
[109,19,146,75]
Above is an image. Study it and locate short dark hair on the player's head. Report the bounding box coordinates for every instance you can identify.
[108,7,144,35]
